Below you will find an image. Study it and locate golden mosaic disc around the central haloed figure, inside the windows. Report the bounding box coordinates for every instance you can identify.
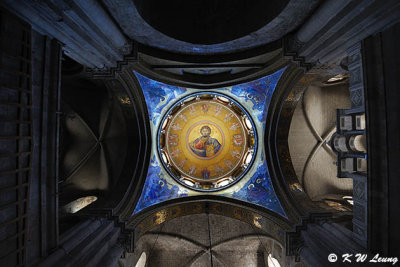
[165,99,247,182]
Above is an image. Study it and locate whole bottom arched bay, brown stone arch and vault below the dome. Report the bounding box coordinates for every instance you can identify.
[120,199,294,267]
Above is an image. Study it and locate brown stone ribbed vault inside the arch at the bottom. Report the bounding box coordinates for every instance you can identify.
[134,214,285,266]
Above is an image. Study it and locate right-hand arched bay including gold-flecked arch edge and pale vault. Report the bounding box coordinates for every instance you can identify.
[277,70,364,229]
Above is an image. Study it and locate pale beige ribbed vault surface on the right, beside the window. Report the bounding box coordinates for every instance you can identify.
[288,81,353,200]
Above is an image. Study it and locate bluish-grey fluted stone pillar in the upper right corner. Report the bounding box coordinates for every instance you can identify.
[287,0,400,65]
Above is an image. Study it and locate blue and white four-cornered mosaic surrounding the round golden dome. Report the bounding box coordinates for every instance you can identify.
[133,68,286,217]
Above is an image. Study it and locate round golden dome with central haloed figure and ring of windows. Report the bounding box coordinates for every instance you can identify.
[157,93,257,191]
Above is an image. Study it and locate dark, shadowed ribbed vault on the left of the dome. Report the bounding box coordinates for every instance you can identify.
[60,85,127,204]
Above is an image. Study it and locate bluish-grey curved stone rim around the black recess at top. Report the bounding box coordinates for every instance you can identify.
[102,0,318,54]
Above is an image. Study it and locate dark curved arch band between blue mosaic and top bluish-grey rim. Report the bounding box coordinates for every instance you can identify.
[132,43,289,89]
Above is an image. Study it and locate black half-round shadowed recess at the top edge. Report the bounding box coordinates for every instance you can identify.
[134,0,289,45]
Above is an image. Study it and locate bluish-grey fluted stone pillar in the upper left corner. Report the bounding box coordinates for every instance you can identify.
[1,0,131,69]
